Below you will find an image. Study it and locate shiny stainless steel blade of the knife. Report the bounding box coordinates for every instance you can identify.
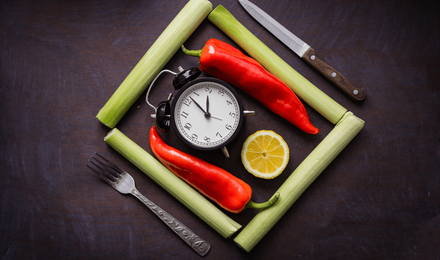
[238,0,310,58]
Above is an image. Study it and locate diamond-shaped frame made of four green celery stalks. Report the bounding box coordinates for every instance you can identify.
[97,0,364,252]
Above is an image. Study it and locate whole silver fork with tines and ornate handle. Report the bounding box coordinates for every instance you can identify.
[86,152,211,256]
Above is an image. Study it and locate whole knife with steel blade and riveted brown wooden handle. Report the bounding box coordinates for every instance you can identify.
[238,0,367,101]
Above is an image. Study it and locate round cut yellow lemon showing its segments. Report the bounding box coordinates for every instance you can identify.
[241,130,289,179]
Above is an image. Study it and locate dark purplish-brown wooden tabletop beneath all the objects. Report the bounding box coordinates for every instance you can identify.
[0,0,440,260]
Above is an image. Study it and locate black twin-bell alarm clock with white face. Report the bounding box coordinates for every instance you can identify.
[146,67,255,158]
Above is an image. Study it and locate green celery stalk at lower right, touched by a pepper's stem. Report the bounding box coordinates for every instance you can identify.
[234,112,364,252]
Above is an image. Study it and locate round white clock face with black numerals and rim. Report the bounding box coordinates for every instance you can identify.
[171,78,243,150]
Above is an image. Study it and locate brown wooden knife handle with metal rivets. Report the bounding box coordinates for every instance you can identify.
[303,48,367,101]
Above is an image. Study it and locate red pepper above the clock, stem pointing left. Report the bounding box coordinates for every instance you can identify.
[182,39,319,134]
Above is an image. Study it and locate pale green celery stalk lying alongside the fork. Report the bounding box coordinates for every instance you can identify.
[104,128,241,238]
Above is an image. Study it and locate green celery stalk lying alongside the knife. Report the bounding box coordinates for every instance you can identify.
[208,5,347,124]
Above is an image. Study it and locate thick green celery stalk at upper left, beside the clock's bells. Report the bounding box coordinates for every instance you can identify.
[96,0,212,128]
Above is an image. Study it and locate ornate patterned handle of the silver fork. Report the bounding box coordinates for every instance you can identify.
[131,188,211,256]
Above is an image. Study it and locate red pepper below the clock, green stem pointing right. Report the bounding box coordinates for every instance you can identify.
[150,126,279,213]
